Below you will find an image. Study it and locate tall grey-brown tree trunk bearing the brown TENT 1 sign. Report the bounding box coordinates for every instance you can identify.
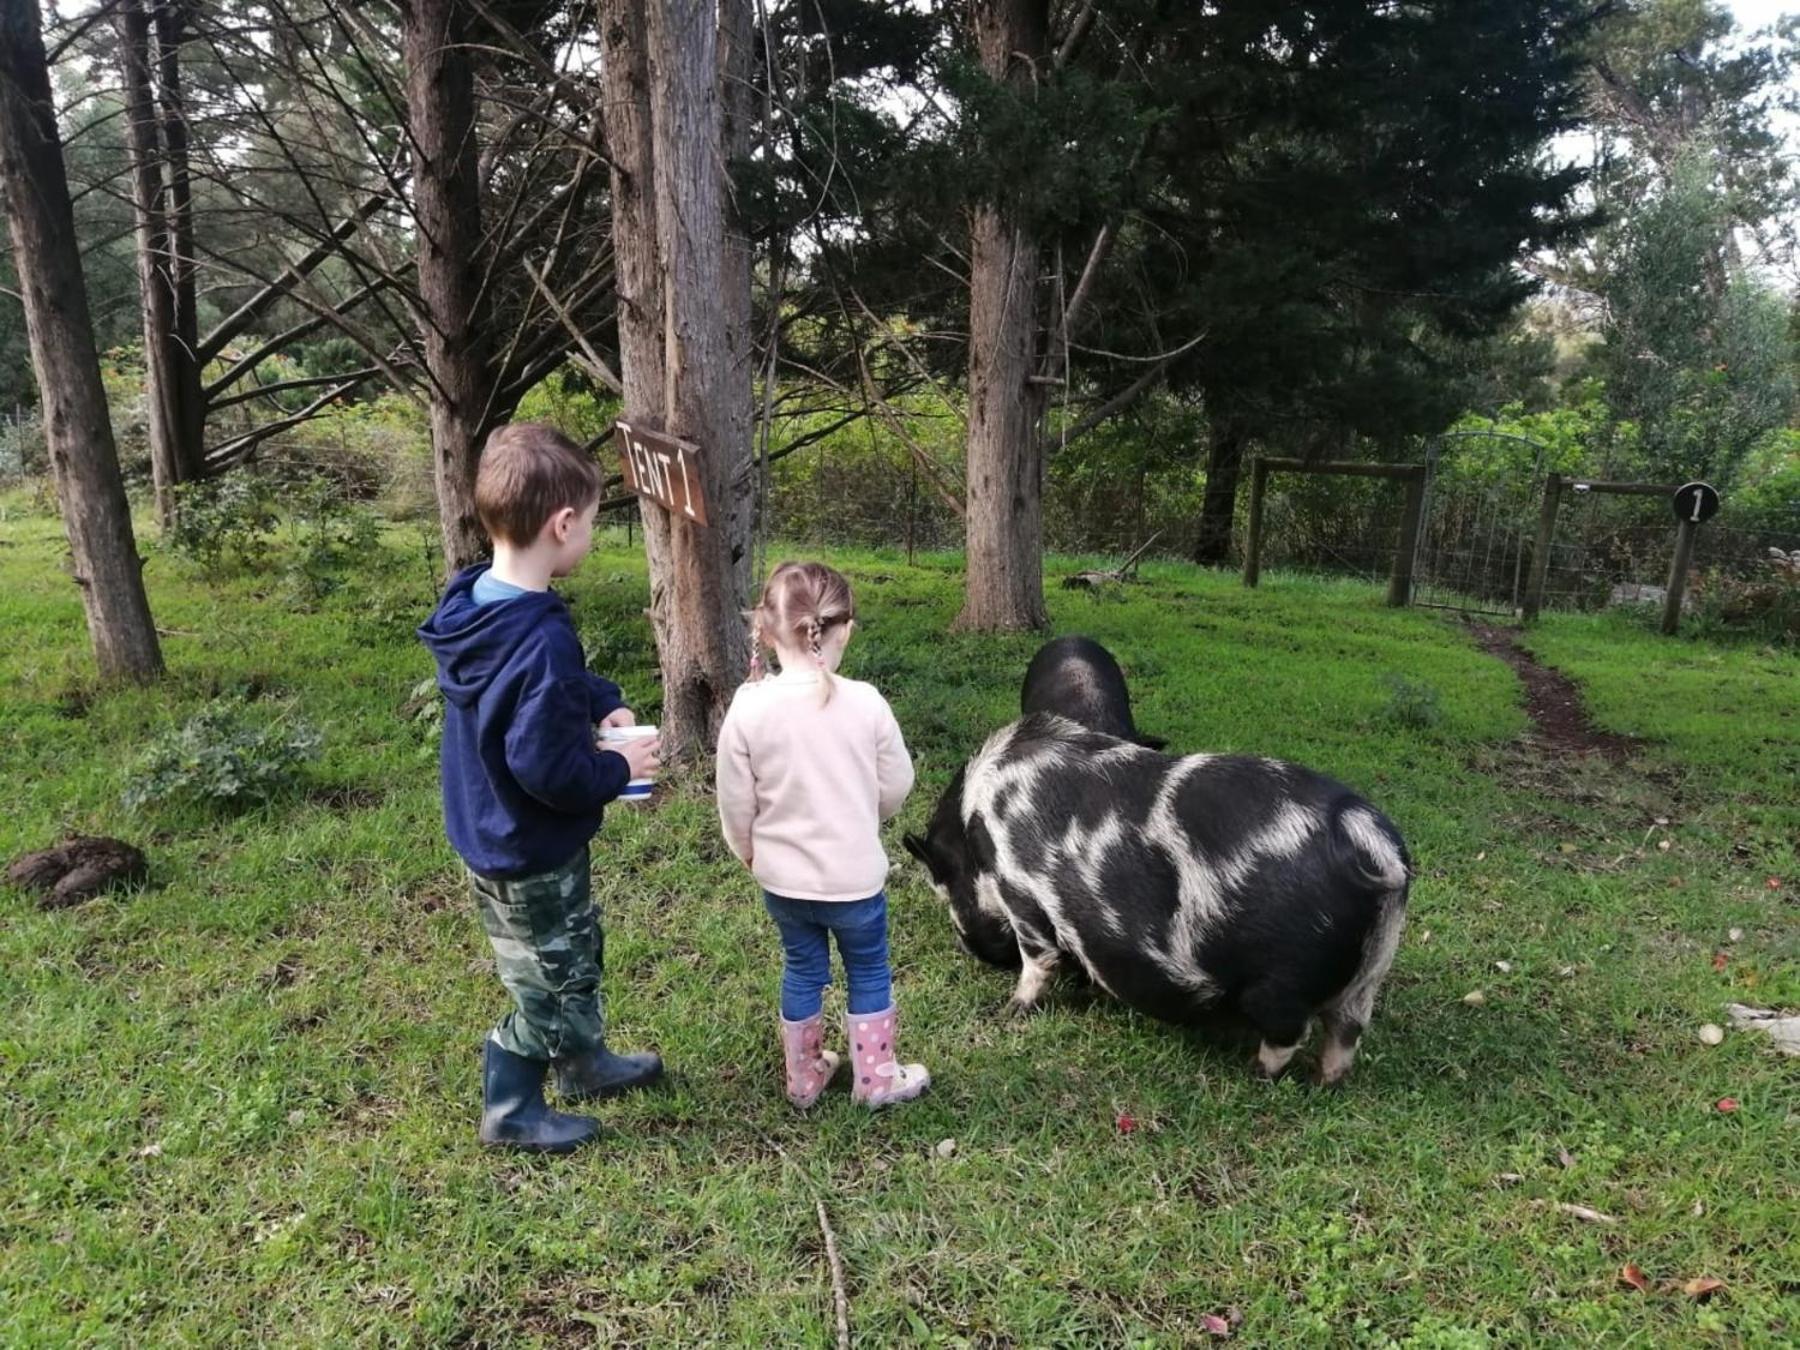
[622,0,751,760]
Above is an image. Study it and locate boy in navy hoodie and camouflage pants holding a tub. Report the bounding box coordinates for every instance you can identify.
[419,423,662,1154]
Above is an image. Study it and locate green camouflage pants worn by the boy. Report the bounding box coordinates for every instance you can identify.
[470,848,607,1060]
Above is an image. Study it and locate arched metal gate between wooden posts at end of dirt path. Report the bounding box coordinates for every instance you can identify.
[1413,430,1544,617]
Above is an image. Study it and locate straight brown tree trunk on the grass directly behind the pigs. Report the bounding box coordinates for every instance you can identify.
[956,0,1049,632]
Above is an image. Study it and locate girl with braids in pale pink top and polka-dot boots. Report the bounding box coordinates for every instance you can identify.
[718,563,931,1109]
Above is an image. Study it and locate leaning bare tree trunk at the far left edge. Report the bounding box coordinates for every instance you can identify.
[0,0,162,682]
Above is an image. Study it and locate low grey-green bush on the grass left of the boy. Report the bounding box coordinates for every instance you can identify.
[124,700,324,810]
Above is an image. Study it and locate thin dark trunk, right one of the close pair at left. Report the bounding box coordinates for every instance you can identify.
[155,0,207,482]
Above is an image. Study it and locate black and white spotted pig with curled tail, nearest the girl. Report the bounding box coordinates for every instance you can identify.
[905,715,1411,1084]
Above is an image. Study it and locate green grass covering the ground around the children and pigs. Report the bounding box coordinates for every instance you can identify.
[0,495,1800,1346]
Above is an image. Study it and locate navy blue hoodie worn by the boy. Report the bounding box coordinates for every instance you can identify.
[419,563,632,880]
